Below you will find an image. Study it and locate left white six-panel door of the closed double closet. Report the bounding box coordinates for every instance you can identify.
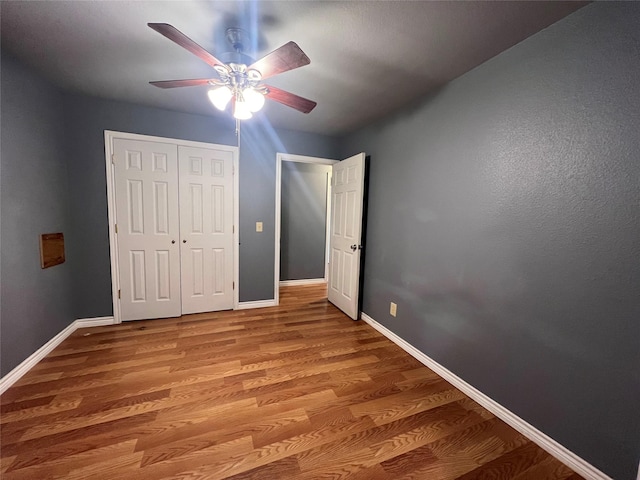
[112,138,180,320]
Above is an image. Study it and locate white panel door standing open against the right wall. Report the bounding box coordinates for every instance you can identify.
[328,153,365,320]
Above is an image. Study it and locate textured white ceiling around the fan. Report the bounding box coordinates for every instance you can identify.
[0,0,585,134]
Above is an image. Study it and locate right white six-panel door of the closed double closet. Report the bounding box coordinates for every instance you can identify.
[178,146,234,314]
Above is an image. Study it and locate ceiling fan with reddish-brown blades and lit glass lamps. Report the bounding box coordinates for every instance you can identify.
[147,23,317,120]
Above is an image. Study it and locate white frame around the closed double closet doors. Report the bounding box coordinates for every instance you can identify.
[104,130,240,324]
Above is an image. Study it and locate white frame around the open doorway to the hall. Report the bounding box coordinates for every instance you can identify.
[273,153,340,305]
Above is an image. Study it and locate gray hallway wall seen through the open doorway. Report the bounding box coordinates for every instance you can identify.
[280,162,331,280]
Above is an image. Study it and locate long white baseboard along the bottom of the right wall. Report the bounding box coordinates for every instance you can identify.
[361,312,612,480]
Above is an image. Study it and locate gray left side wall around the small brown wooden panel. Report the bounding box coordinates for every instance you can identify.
[0,52,75,376]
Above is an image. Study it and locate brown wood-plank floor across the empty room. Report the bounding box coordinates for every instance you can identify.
[0,286,582,480]
